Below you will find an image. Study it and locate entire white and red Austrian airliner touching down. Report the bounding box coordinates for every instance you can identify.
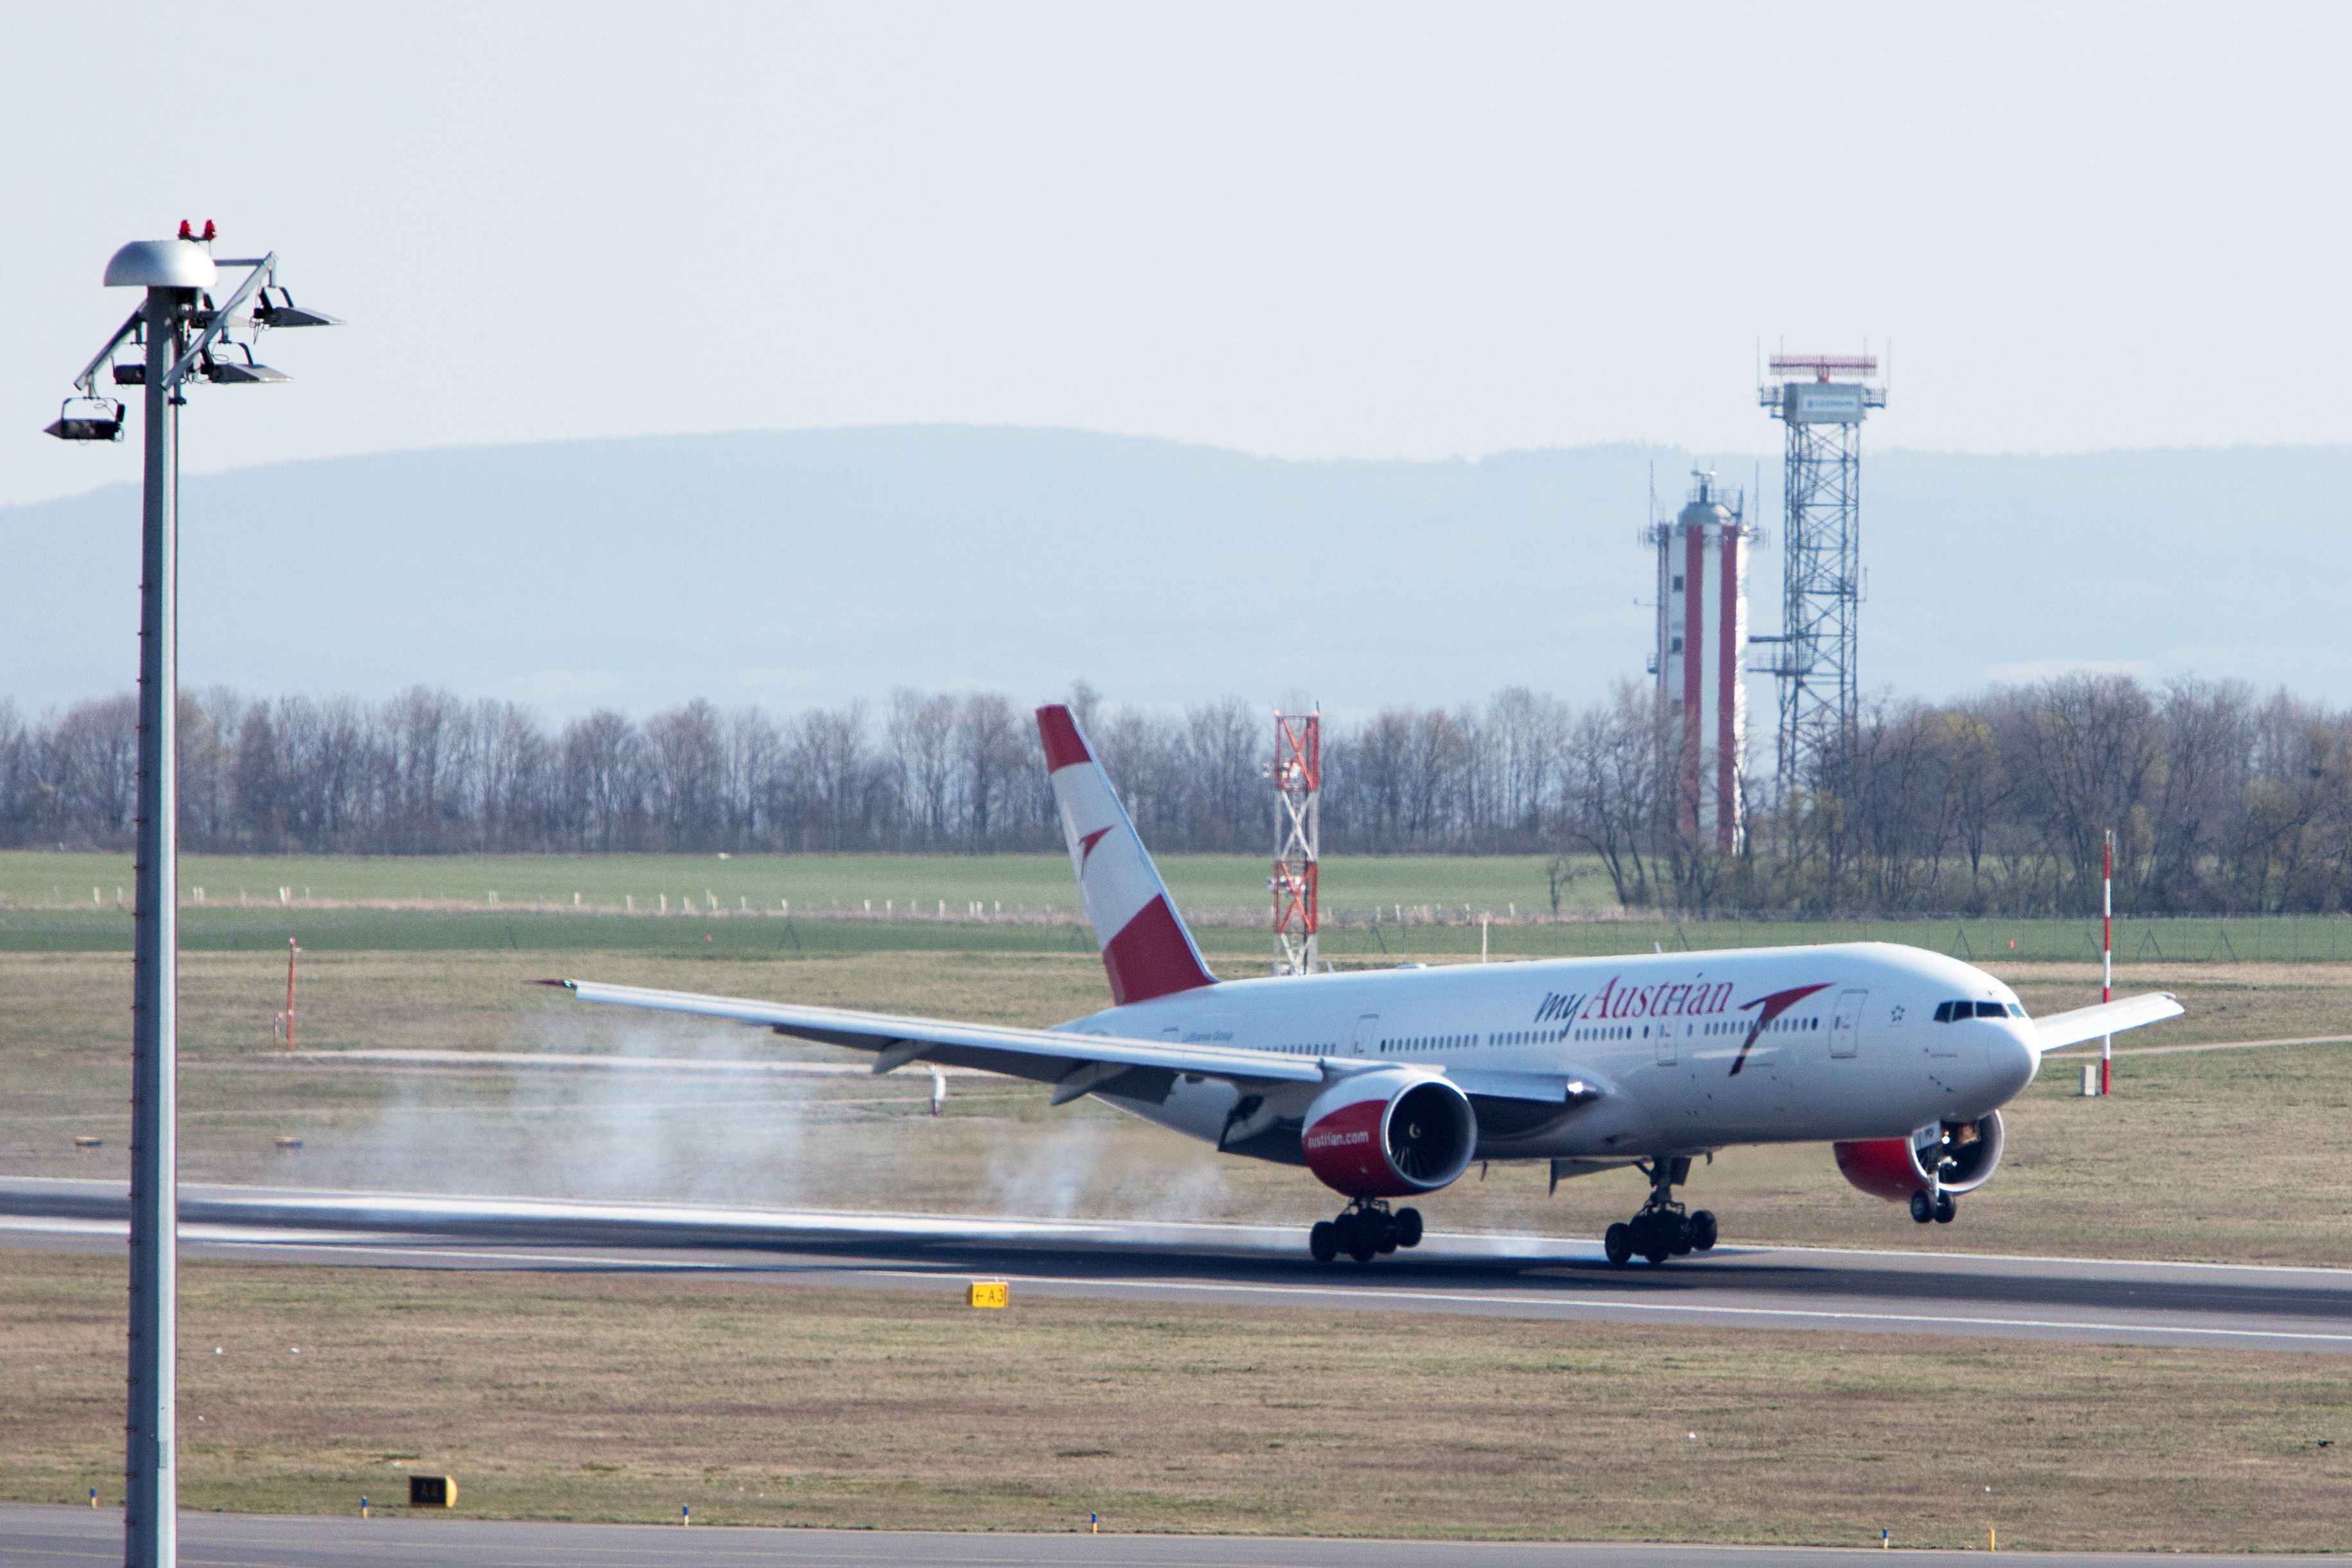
[546,705,2183,1267]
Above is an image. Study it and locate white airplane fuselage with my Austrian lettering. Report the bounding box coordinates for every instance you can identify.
[1063,943,2039,1159]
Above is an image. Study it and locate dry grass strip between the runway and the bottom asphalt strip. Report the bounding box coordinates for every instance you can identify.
[0,1253,2352,1551]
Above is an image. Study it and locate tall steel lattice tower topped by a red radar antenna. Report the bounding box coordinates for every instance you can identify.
[1752,355,1887,795]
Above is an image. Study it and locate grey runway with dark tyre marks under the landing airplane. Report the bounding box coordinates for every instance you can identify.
[0,1178,2352,1354]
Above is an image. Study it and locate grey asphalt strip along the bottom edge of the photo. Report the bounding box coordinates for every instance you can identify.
[0,1504,2310,1568]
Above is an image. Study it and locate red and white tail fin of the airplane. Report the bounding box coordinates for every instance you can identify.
[1037,703,1216,1006]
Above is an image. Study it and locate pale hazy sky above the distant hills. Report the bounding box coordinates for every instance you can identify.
[0,0,2352,503]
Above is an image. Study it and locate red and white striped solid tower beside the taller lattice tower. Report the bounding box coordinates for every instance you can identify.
[1644,468,1754,854]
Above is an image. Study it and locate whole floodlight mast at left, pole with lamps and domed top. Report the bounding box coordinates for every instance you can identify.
[52,223,334,1568]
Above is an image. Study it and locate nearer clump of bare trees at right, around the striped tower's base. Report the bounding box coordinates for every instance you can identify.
[1559,675,2352,915]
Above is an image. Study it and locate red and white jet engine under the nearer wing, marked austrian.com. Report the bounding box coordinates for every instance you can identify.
[1301,1067,1477,1199]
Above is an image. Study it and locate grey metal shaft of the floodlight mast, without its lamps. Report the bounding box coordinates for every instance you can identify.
[123,287,191,1568]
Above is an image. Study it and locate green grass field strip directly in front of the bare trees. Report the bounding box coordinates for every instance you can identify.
[13,851,2352,973]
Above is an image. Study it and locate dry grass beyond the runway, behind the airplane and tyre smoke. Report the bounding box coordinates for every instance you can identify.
[0,952,2352,1265]
